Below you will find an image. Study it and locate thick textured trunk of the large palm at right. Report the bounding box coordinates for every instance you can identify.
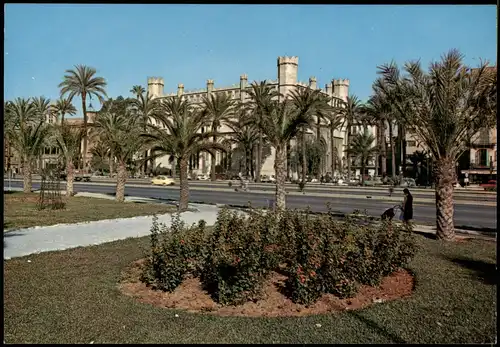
[434,157,455,241]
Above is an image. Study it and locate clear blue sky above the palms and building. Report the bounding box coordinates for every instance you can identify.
[4,4,497,116]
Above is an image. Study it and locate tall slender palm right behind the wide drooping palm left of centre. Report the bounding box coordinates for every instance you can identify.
[202,93,235,181]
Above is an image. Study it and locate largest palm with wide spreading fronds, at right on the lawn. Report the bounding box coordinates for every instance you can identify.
[377,49,497,240]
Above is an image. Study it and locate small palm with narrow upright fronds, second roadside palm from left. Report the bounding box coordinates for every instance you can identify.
[52,123,84,197]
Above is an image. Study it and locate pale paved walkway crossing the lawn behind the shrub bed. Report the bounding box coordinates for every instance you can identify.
[4,193,496,259]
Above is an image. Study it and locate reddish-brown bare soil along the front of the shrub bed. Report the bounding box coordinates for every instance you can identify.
[119,260,414,317]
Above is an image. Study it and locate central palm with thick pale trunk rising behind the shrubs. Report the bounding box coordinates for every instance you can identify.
[261,100,309,210]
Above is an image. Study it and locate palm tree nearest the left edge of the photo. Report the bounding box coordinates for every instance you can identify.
[5,98,50,193]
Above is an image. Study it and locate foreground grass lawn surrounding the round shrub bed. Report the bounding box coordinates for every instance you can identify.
[4,232,496,344]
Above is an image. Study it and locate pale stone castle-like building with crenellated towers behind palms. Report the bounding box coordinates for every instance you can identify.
[148,57,349,179]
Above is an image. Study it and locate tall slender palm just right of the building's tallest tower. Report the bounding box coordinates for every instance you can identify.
[290,88,330,182]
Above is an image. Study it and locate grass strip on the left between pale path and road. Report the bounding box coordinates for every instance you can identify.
[4,192,176,231]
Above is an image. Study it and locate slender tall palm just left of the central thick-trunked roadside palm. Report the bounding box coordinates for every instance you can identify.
[248,80,279,182]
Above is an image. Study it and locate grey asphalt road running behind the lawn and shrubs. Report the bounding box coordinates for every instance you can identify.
[4,181,497,229]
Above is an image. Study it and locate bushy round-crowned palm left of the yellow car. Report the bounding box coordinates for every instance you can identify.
[92,112,144,202]
